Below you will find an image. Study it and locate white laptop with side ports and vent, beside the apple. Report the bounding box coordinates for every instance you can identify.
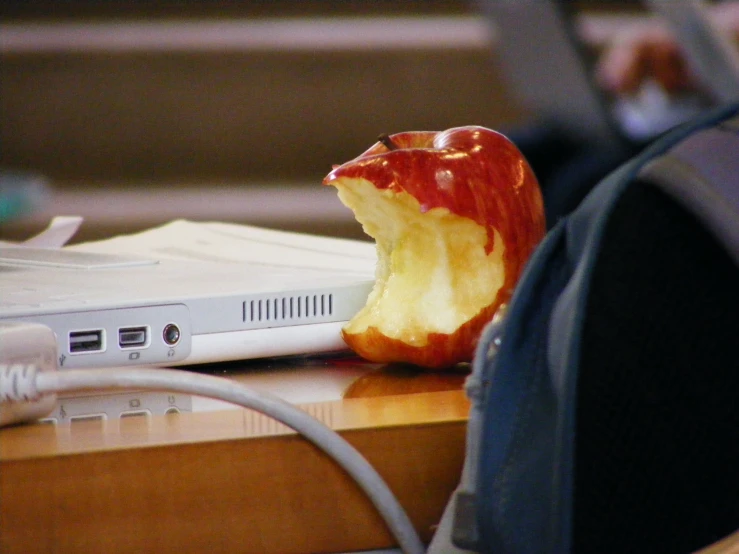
[0,221,376,369]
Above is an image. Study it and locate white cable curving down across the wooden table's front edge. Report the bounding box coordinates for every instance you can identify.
[13,369,425,554]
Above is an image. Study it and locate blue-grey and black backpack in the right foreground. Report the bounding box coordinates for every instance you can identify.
[430,105,739,554]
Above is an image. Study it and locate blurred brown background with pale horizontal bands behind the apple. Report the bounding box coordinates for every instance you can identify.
[0,0,700,241]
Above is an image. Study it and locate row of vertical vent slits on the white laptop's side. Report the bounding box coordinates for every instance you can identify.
[244,294,334,323]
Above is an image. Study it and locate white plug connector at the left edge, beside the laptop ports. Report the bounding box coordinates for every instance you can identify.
[0,322,57,427]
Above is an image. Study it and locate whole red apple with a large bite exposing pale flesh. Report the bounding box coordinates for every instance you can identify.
[323,126,545,368]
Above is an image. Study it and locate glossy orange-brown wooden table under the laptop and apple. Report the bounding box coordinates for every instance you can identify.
[0,358,469,554]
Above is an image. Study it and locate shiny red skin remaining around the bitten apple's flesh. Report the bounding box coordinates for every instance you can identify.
[323,126,545,368]
